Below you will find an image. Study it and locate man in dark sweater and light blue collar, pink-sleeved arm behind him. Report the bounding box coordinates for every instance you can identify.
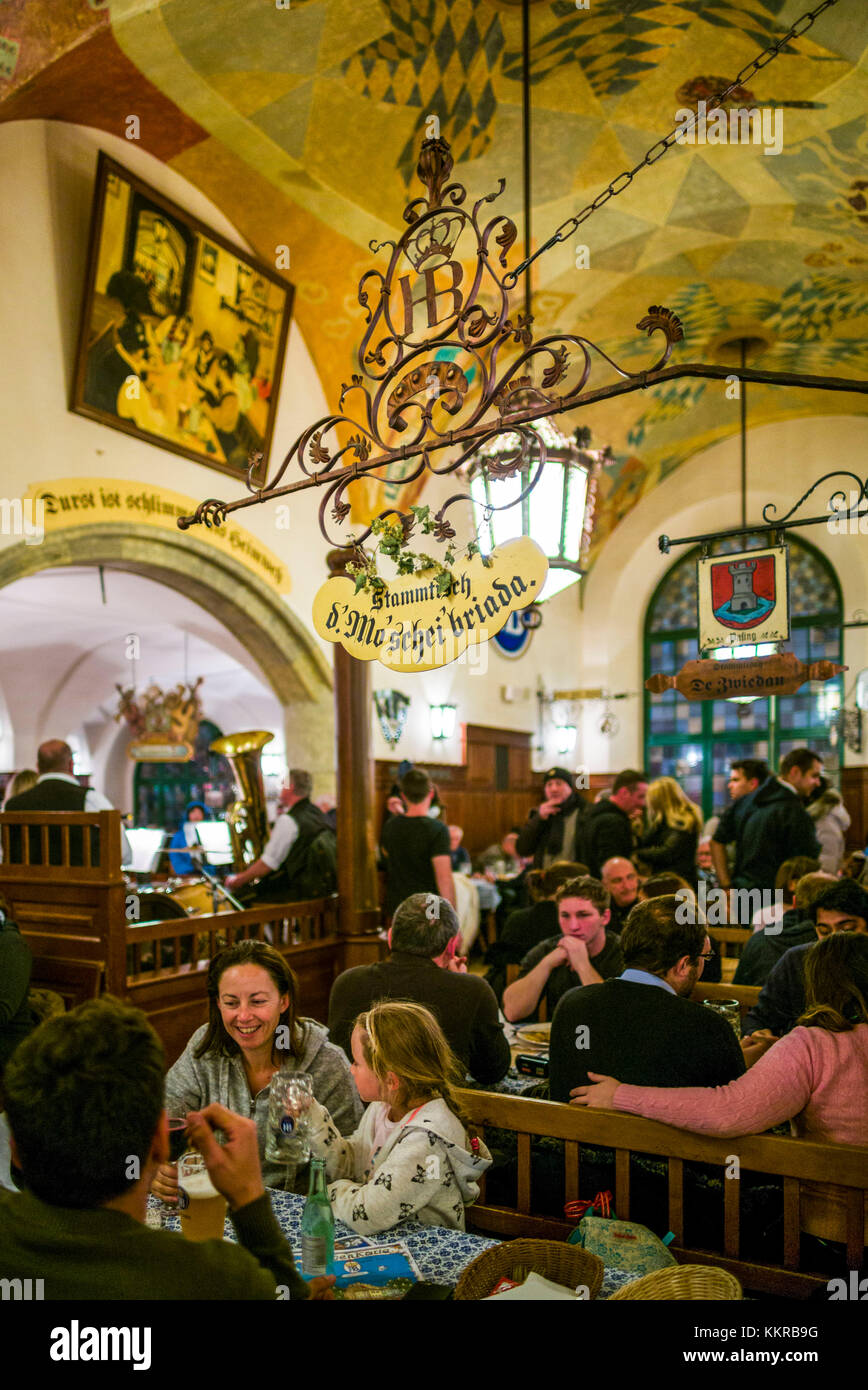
[549,897,744,1101]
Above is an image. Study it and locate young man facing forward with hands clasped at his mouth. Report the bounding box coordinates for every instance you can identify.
[504,874,623,1023]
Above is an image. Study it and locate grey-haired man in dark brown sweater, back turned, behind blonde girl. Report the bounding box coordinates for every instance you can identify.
[328,892,509,1086]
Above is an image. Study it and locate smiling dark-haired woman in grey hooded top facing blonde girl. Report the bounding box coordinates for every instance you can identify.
[153,941,362,1201]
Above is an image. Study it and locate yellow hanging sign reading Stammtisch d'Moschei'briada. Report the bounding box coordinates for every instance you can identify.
[313,537,548,671]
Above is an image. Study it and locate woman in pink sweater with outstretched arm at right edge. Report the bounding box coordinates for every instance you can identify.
[570,931,868,1144]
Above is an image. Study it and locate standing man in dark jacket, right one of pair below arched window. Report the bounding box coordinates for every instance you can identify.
[733,748,822,892]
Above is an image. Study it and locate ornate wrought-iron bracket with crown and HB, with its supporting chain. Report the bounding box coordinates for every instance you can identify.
[178,0,868,549]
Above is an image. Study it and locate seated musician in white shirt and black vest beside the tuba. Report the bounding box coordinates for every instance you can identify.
[225,767,334,902]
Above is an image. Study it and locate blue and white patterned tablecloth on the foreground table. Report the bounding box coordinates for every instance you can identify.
[147,1188,636,1298]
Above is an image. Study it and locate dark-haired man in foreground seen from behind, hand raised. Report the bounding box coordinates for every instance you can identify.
[0,997,334,1300]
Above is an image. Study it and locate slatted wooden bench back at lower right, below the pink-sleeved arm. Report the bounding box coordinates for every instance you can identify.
[458,1091,868,1298]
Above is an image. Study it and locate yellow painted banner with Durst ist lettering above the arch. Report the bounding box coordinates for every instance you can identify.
[24,478,291,594]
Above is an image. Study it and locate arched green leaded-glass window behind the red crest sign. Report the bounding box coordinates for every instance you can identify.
[645,535,842,816]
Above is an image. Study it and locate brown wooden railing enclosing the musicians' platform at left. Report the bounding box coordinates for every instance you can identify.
[0,810,344,1062]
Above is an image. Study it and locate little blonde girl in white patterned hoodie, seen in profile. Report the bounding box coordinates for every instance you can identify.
[310,1001,491,1234]
